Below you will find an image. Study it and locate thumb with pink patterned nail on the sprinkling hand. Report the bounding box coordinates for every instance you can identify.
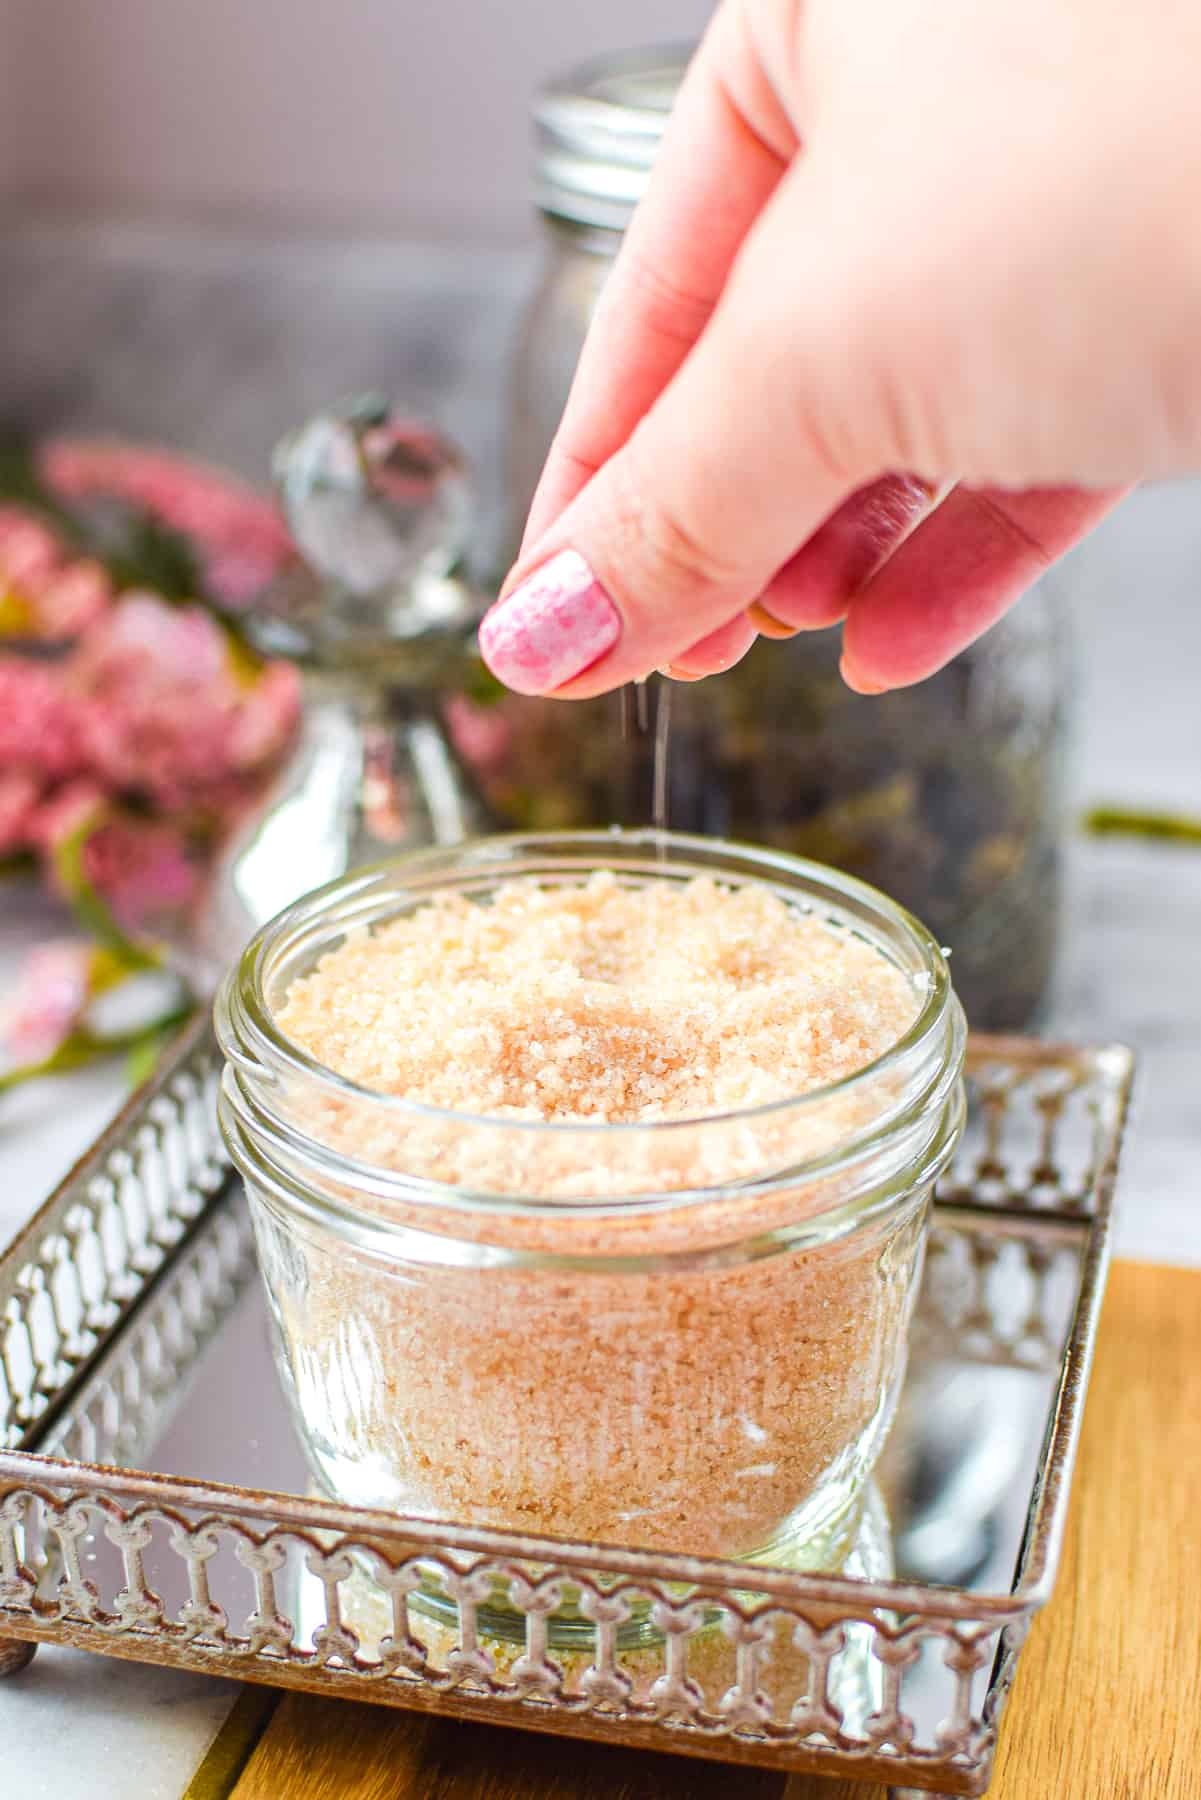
[479,160,882,698]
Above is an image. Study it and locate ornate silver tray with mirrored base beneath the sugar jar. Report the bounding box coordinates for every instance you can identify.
[0,1022,1131,1795]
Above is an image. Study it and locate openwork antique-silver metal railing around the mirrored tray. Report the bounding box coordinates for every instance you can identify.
[0,1022,1133,1793]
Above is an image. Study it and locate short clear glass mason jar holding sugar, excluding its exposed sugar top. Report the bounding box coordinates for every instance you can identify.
[216,832,965,1591]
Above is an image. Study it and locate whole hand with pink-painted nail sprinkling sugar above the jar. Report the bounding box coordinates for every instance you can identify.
[481,0,1201,698]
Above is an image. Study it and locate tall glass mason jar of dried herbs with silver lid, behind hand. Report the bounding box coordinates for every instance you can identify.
[496,50,1068,1031]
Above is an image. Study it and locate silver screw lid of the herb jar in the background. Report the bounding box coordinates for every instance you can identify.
[533,43,693,232]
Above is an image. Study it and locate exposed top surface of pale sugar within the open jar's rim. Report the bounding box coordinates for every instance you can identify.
[279,871,917,1123]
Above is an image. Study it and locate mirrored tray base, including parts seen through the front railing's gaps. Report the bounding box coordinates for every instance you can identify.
[4,1190,1082,1764]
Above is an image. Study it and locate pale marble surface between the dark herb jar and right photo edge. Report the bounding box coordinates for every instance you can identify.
[1046,481,1201,1264]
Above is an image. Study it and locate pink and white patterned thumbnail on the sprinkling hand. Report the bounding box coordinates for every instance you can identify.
[479,551,621,693]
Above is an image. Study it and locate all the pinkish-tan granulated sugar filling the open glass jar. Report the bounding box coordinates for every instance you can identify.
[264,873,927,1555]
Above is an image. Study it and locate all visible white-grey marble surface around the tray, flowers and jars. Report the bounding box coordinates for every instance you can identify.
[0,232,1201,1800]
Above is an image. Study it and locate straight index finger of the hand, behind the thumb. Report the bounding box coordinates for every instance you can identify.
[522,5,796,553]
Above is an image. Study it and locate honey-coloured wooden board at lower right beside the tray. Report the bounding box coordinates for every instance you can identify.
[989,1260,1201,1800]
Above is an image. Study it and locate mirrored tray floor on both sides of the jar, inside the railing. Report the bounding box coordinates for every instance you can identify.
[40,1188,1082,1591]
